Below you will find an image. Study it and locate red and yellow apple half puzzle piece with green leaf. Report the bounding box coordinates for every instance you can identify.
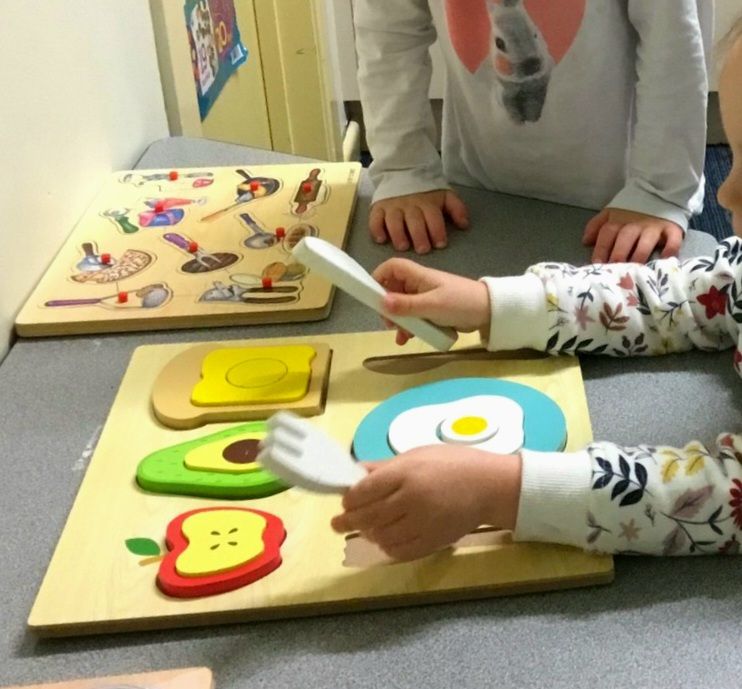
[140,507,286,598]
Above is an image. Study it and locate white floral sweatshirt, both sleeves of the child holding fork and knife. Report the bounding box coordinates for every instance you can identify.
[484,238,742,555]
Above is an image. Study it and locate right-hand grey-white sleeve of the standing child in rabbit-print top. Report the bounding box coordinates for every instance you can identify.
[608,0,708,229]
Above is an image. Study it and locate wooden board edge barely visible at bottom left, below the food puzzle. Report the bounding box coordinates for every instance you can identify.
[5,667,214,689]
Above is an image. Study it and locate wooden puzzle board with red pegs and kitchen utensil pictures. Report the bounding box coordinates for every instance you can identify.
[16,163,361,336]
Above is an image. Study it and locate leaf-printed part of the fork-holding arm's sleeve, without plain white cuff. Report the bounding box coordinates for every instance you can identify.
[575,435,742,555]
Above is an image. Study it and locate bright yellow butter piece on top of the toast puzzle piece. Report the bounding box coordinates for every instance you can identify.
[191,345,316,407]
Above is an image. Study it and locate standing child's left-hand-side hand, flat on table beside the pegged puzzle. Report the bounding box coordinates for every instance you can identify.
[369,189,469,254]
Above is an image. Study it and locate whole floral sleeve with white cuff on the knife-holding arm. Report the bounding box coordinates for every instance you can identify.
[485,239,742,357]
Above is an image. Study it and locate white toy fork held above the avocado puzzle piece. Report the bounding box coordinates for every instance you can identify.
[257,411,366,493]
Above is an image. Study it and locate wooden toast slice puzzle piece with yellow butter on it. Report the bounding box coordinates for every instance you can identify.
[152,343,331,429]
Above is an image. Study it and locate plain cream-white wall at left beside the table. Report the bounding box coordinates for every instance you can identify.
[0,0,168,359]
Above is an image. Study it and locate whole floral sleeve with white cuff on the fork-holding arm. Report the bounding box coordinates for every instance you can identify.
[514,434,742,555]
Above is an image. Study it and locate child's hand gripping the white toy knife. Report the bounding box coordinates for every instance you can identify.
[373,258,490,345]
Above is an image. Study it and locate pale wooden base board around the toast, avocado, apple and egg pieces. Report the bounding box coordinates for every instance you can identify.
[28,332,613,635]
